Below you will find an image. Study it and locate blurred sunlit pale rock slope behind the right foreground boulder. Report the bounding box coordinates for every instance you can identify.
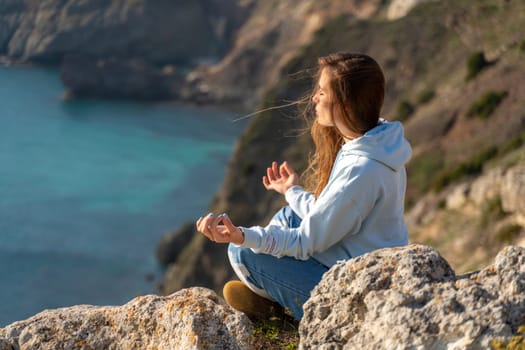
[406,159,525,272]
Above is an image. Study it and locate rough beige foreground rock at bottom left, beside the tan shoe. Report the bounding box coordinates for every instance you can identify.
[0,287,252,350]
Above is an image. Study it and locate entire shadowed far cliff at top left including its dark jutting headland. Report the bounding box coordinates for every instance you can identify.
[0,0,251,100]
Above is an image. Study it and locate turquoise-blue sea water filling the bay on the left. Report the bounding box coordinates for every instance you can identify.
[0,67,242,327]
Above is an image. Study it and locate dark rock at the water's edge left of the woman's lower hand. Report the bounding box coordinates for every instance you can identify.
[156,223,195,265]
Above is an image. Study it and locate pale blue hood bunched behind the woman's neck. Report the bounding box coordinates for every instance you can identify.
[342,119,412,171]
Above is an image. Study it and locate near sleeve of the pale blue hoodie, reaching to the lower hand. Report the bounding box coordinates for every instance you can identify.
[237,161,376,260]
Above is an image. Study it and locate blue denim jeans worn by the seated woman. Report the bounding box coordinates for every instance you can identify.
[228,206,328,320]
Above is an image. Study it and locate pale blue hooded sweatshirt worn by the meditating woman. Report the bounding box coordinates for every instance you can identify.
[241,120,412,267]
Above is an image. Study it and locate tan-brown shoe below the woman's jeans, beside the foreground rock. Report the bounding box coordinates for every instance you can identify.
[222,281,284,320]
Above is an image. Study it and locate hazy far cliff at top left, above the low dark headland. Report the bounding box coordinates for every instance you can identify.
[0,0,244,64]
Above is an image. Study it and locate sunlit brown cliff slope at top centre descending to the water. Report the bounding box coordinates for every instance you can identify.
[185,0,384,108]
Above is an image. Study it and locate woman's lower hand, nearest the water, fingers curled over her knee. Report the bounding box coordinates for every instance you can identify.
[196,213,244,244]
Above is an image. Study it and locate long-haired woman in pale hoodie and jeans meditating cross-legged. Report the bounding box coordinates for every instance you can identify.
[196,53,411,319]
